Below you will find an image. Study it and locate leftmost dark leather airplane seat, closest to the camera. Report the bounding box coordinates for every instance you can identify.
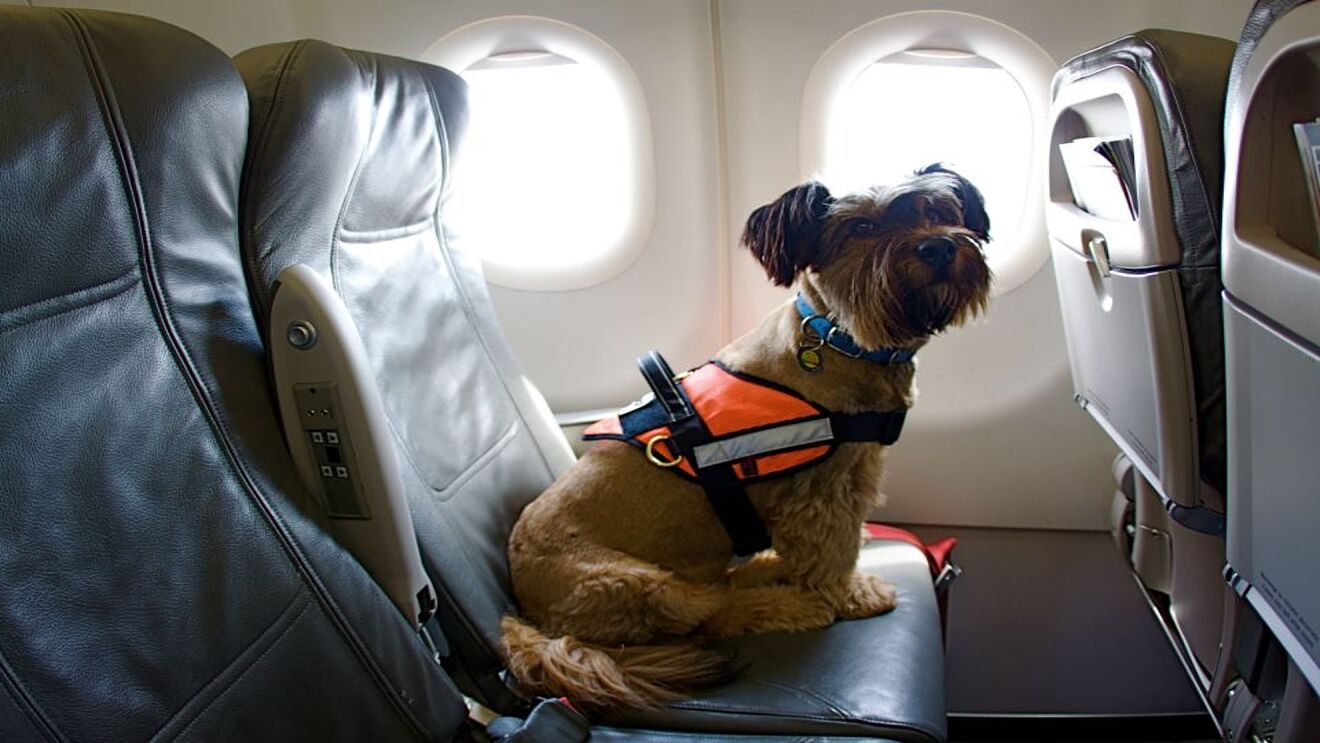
[0,5,466,740]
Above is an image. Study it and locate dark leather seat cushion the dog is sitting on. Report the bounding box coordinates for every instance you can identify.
[602,541,945,743]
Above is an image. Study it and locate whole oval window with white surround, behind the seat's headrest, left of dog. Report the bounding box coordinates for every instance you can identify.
[424,17,653,290]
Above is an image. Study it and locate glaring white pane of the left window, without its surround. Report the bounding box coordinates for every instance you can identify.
[446,54,634,273]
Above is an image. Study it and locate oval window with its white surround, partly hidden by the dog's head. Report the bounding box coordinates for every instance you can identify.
[800,11,1057,294]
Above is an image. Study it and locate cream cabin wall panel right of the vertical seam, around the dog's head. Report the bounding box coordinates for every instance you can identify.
[721,0,1251,529]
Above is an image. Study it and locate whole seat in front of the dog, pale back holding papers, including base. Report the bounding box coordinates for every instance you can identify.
[1045,29,1234,694]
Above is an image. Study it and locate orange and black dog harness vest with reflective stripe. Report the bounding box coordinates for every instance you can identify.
[582,351,907,554]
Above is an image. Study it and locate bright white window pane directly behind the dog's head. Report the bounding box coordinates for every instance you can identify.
[824,57,1032,251]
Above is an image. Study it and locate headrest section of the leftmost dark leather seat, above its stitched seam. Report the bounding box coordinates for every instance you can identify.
[0,7,247,323]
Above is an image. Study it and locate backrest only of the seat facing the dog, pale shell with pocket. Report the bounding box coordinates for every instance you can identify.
[1047,30,1233,512]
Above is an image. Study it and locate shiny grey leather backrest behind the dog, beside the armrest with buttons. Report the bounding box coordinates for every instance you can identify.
[235,41,572,710]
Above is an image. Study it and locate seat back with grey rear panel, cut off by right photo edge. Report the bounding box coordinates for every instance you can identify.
[1217,0,1320,743]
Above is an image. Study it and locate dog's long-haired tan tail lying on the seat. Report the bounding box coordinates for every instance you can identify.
[500,616,737,710]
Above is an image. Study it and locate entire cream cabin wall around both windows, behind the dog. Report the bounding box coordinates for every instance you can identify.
[18,0,1251,529]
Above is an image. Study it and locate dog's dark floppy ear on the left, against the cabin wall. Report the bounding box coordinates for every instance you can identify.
[742,181,834,286]
